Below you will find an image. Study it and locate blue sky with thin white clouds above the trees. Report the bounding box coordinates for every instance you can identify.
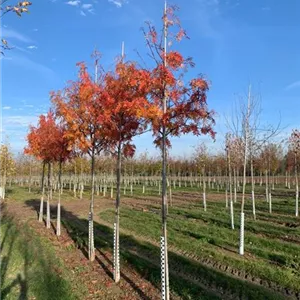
[1,0,300,156]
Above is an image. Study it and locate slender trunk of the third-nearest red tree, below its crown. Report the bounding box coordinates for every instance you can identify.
[88,149,95,261]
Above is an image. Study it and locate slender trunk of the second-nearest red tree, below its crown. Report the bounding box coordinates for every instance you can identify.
[114,142,122,282]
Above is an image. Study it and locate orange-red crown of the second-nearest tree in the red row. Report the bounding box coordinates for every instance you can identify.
[104,61,156,156]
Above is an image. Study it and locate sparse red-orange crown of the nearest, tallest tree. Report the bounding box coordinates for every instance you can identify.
[144,3,215,147]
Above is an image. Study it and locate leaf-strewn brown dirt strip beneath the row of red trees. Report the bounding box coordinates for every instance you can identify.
[0,200,166,300]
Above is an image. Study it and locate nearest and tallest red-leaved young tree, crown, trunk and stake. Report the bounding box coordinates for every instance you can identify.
[144,2,215,300]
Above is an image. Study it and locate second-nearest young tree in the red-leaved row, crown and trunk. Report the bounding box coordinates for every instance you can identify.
[103,57,152,282]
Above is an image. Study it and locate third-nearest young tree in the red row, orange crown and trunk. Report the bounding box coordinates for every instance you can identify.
[52,59,109,261]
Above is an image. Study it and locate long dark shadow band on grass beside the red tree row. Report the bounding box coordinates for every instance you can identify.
[26,201,286,300]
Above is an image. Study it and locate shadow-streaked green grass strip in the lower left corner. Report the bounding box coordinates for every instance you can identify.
[0,203,78,300]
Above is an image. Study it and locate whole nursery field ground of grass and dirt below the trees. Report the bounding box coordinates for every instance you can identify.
[0,185,300,299]
